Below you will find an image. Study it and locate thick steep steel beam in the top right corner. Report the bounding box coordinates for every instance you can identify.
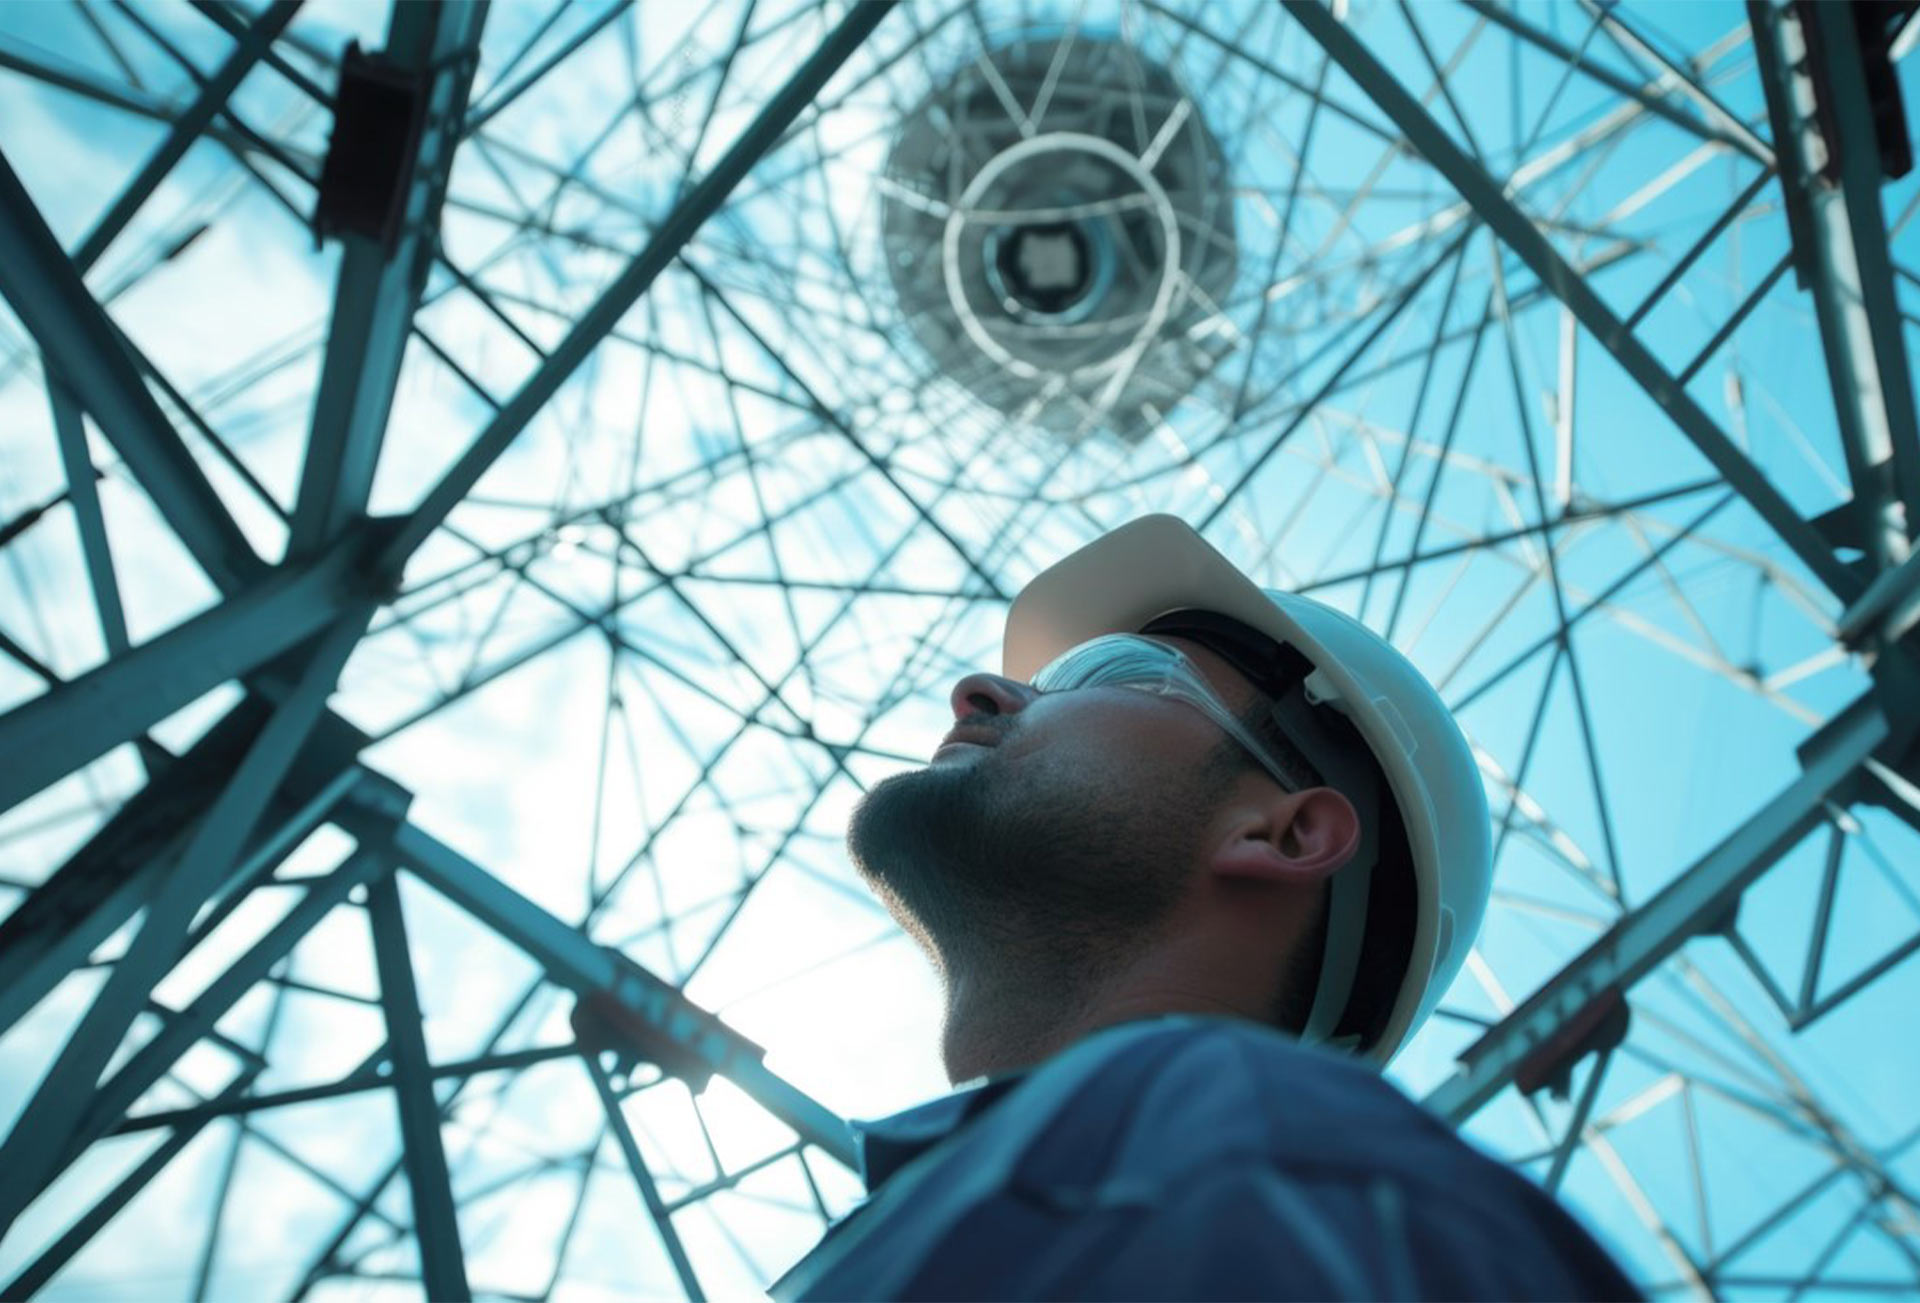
[1747,0,1920,572]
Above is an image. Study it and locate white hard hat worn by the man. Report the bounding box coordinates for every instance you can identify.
[1000,516,1494,1065]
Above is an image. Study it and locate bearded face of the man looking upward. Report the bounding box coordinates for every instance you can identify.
[847,637,1254,971]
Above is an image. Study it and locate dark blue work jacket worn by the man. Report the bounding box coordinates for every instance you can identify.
[770,1015,1642,1303]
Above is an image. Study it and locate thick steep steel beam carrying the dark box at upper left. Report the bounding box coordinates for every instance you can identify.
[286,0,488,558]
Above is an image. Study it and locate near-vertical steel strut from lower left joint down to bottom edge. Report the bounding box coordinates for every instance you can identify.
[367,873,472,1299]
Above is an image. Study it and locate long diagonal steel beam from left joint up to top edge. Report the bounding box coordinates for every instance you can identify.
[382,0,897,574]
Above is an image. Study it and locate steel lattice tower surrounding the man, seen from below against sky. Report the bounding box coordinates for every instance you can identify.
[0,0,1920,1299]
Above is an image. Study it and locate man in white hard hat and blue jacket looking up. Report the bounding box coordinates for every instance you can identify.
[772,516,1638,1299]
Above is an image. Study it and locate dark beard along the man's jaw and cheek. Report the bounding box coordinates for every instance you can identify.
[847,752,1206,998]
